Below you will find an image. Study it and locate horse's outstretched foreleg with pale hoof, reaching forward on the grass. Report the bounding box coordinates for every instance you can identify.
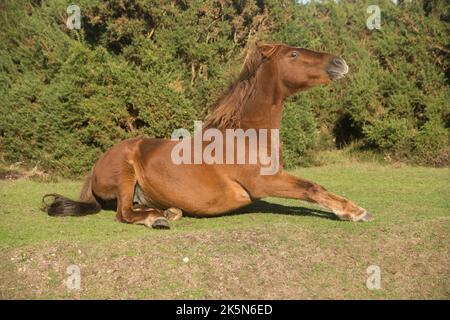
[264,172,370,221]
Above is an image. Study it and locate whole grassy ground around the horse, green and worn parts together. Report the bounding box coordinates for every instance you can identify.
[0,162,450,299]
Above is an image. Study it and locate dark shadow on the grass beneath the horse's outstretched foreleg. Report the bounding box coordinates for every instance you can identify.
[225,200,339,220]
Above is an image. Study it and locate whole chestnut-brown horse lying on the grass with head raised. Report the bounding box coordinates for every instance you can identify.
[44,44,369,228]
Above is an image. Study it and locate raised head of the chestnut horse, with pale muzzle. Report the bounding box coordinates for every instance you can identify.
[257,44,348,95]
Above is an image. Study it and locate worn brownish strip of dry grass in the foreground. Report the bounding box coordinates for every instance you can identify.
[0,220,450,299]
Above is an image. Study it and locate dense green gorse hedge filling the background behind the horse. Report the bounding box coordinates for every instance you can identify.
[0,0,450,175]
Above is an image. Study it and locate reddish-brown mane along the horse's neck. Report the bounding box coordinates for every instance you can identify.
[204,45,275,129]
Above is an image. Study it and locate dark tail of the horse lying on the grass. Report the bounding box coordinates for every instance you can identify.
[42,174,101,216]
